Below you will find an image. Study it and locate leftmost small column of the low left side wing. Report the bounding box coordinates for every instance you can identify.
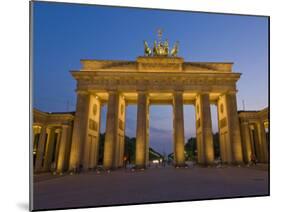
[35,126,47,172]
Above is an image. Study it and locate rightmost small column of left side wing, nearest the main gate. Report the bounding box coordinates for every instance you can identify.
[57,125,70,173]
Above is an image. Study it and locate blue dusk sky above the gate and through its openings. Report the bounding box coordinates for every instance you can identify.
[32,2,268,153]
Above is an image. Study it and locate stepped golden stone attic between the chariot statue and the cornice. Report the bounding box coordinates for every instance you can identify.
[81,56,233,72]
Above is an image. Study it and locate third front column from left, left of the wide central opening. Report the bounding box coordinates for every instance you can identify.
[136,91,149,168]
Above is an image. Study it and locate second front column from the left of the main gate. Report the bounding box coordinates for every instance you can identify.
[103,91,119,169]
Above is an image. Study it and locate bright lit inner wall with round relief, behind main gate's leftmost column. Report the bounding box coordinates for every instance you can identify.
[83,95,101,170]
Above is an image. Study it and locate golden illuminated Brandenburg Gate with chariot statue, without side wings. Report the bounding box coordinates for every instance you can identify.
[69,35,243,170]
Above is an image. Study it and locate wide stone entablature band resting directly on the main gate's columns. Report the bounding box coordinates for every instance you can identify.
[71,71,240,91]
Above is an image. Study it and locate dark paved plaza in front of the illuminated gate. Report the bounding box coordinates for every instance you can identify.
[34,165,269,209]
